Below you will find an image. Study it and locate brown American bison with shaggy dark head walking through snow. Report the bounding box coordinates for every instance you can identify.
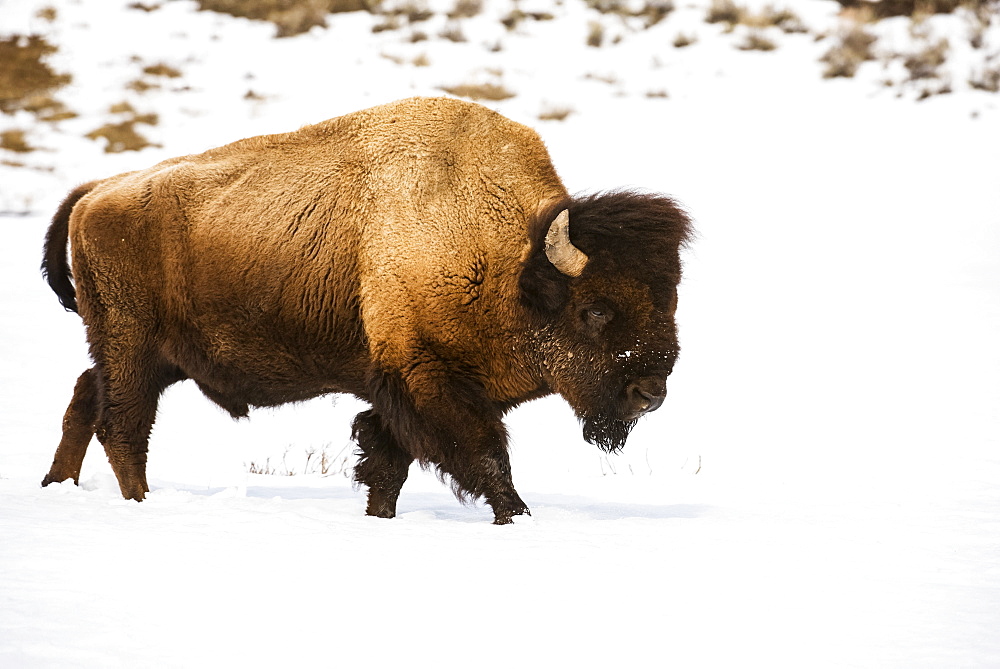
[42,98,690,524]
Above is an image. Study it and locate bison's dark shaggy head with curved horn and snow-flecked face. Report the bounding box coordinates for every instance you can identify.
[520,192,690,451]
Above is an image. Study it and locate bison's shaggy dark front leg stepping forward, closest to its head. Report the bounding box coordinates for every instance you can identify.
[372,363,530,525]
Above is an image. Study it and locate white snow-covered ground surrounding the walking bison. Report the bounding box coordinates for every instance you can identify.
[0,0,1000,668]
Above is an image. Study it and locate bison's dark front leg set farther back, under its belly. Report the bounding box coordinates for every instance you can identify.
[352,409,413,518]
